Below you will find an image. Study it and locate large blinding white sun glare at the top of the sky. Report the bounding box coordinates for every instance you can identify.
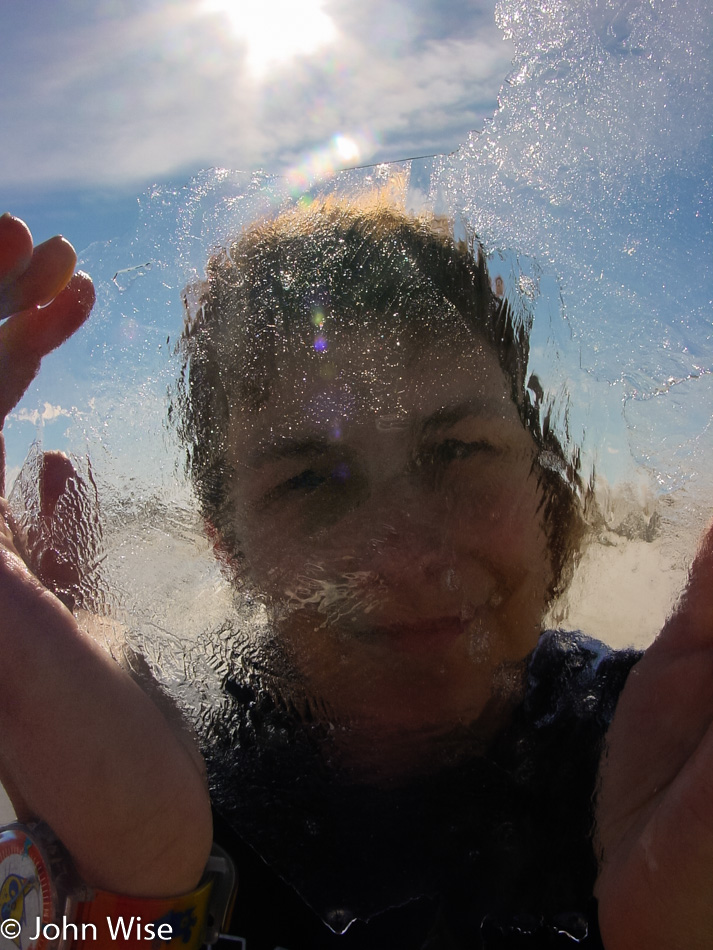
[201,0,336,77]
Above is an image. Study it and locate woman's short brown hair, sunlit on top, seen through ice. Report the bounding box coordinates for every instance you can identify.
[178,198,586,595]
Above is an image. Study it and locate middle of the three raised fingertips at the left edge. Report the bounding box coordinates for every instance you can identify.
[0,237,77,317]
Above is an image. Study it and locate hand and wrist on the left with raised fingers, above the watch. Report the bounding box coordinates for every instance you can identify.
[0,216,212,896]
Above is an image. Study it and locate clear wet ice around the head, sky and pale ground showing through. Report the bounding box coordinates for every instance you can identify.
[2,0,713,924]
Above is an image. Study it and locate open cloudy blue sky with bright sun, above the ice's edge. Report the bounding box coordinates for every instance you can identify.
[0,0,512,249]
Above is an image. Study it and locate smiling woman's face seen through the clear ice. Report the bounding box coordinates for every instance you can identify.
[220,321,552,776]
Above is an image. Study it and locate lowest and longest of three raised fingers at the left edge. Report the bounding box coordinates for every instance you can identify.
[0,273,95,425]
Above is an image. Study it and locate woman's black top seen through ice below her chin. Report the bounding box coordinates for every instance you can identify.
[208,631,640,950]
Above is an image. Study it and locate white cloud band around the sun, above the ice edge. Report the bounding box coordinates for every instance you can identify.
[0,0,511,188]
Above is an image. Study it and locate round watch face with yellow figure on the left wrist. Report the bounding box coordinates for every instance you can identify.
[0,828,55,950]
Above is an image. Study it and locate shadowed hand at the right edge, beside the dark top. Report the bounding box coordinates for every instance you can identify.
[596,528,713,950]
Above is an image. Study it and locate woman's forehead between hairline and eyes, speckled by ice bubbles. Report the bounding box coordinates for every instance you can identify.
[229,326,520,446]
